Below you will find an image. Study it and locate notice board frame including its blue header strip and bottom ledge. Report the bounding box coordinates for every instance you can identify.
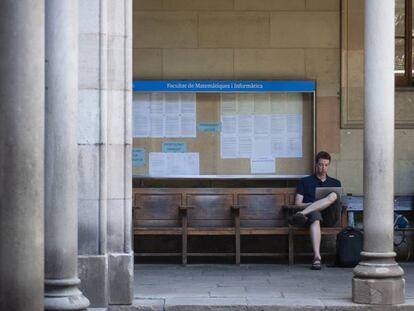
[133,80,317,179]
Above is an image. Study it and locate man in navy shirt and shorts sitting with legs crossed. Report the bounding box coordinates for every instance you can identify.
[289,151,341,270]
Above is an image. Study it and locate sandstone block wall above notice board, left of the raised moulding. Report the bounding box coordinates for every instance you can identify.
[133,0,340,180]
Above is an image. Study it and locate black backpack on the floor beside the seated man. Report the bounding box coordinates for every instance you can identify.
[336,227,363,267]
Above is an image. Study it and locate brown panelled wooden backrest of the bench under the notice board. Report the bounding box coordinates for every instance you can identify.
[133,188,295,227]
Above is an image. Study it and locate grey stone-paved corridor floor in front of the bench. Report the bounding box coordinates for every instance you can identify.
[115,263,414,310]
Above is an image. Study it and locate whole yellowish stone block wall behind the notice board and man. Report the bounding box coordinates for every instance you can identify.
[133,0,414,194]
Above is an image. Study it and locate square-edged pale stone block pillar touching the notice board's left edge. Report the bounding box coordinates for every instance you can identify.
[78,0,133,307]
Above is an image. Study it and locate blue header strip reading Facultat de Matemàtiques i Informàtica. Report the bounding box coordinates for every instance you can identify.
[133,80,316,93]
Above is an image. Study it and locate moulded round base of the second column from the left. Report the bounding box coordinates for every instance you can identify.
[44,278,89,311]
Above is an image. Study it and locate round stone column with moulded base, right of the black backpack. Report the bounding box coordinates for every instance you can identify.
[352,0,404,305]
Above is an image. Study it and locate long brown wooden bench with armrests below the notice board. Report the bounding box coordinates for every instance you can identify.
[133,188,346,264]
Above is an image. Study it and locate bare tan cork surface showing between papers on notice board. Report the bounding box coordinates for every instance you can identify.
[133,93,314,176]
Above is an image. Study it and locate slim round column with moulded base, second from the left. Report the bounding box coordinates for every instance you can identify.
[44,0,89,310]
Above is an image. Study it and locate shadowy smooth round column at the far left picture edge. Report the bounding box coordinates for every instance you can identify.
[0,0,44,311]
